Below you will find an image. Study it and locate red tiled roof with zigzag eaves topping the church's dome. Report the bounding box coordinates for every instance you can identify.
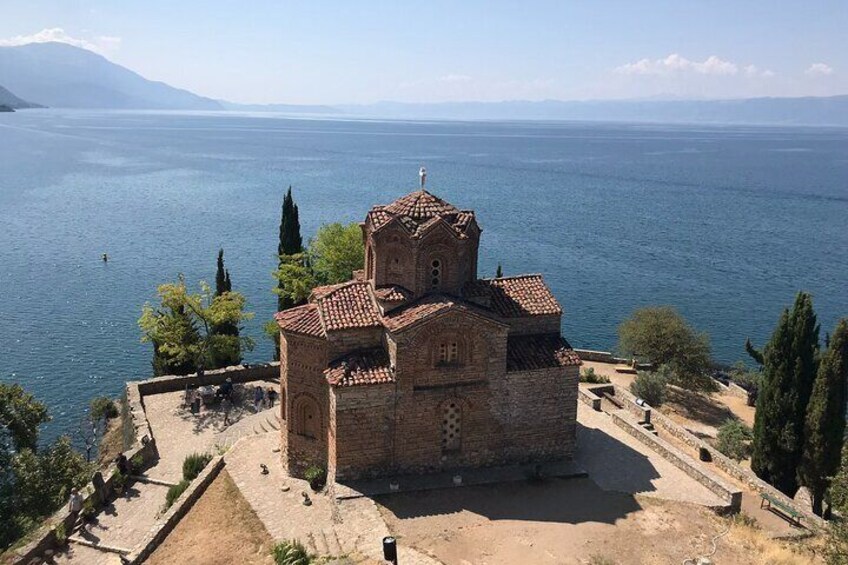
[367,190,474,238]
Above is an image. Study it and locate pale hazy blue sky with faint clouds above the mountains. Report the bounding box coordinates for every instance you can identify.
[0,0,848,104]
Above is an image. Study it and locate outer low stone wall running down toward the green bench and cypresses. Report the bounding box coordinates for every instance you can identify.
[615,386,828,531]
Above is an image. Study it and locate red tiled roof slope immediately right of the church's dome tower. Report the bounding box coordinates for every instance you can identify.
[462,275,562,318]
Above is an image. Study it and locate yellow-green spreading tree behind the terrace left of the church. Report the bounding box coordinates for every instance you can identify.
[138,275,253,374]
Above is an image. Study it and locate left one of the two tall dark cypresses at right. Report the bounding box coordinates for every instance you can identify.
[751,293,819,496]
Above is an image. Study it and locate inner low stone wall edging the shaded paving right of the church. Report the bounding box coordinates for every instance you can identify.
[610,410,742,513]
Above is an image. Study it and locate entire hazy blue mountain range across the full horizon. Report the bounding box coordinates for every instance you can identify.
[0,43,848,126]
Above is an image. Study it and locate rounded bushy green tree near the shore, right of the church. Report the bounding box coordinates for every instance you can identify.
[618,306,715,391]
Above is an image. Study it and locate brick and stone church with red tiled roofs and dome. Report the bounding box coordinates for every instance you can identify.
[276,190,580,481]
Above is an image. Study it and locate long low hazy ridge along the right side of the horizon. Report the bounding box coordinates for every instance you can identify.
[339,95,848,126]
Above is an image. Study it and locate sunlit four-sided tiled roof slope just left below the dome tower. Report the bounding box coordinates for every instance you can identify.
[312,281,382,332]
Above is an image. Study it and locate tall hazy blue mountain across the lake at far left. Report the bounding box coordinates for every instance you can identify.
[0,43,223,110]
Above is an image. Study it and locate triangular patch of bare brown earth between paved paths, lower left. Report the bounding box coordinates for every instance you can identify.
[145,469,274,565]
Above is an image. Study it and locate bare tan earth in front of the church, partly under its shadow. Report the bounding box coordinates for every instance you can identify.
[380,479,820,565]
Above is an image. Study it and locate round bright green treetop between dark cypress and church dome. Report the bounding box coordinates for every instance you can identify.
[309,222,365,284]
